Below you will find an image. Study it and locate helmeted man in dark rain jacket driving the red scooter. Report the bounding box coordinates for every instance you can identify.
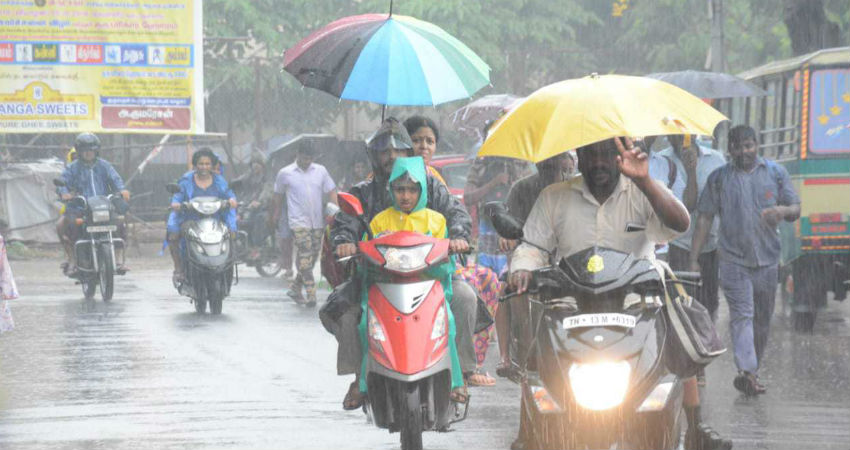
[331,118,477,410]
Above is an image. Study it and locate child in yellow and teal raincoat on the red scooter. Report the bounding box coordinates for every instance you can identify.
[358,156,468,402]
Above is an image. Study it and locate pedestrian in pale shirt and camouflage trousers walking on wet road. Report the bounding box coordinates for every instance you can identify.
[272,142,337,306]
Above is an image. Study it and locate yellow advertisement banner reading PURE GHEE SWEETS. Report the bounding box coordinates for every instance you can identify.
[0,0,204,134]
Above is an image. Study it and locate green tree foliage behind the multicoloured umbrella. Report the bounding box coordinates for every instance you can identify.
[204,0,850,139]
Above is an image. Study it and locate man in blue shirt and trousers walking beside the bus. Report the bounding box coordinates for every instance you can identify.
[690,125,800,395]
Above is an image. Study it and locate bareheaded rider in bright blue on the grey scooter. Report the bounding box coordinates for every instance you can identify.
[166,148,236,283]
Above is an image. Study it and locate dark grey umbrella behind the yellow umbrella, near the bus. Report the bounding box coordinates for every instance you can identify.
[644,70,767,99]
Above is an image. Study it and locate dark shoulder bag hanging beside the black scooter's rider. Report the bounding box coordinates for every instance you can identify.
[664,277,726,378]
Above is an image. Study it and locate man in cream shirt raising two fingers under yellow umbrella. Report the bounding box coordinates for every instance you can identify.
[510,138,732,450]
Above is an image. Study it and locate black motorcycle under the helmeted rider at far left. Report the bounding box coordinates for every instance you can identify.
[53,179,124,302]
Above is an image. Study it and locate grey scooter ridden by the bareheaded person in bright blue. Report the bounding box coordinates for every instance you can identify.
[167,184,236,314]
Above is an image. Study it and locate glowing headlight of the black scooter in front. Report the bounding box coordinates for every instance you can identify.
[569,361,632,411]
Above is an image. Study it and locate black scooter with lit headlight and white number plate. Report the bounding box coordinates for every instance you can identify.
[494,205,684,449]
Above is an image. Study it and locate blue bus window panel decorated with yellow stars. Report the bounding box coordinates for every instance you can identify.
[809,68,850,155]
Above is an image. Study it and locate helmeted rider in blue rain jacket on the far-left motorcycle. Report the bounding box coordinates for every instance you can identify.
[58,133,130,274]
